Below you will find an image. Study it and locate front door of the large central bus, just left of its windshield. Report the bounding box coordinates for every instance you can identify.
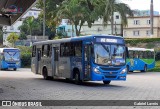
[84,44,91,80]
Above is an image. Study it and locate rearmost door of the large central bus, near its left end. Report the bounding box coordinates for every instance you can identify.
[36,49,41,74]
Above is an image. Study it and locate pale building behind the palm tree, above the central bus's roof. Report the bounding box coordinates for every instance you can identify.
[81,12,123,35]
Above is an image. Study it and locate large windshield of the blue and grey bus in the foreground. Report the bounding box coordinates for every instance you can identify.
[94,44,125,66]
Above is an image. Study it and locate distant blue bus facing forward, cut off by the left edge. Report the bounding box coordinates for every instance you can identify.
[0,48,21,71]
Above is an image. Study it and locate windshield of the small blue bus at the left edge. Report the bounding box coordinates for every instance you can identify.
[4,51,20,61]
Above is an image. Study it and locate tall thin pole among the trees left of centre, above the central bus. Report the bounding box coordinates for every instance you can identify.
[43,0,46,40]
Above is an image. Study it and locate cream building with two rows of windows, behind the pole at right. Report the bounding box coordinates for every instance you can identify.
[123,16,160,38]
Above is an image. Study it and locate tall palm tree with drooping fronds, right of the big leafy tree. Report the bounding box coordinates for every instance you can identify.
[103,0,133,34]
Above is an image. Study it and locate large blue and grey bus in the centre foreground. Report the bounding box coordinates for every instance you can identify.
[31,35,127,84]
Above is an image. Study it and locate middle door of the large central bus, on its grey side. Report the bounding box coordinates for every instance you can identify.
[51,47,60,77]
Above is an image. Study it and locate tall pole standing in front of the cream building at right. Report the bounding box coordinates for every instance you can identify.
[150,0,154,38]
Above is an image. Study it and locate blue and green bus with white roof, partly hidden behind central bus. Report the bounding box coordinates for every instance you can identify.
[127,47,155,72]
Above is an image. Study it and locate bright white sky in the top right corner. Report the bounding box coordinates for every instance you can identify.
[121,0,160,12]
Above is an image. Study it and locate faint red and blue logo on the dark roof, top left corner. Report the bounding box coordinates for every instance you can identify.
[1,5,23,14]
